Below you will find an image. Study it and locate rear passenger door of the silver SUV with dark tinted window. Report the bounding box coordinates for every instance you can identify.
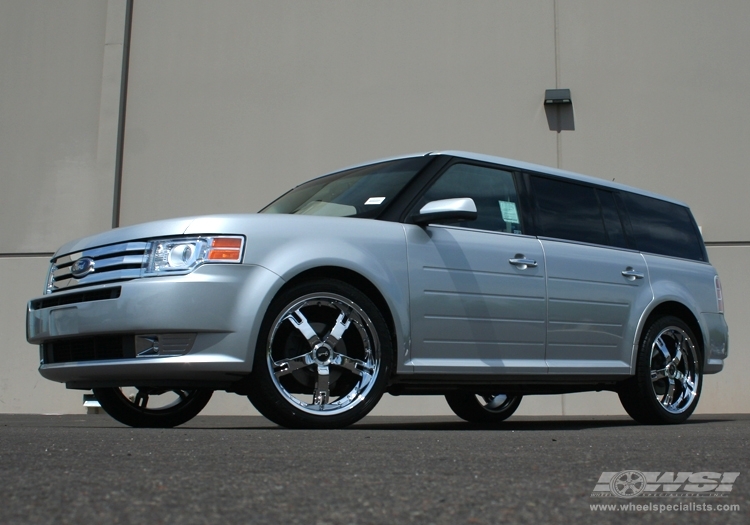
[530,175,652,375]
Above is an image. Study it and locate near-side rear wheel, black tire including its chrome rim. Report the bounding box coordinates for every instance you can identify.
[618,316,703,425]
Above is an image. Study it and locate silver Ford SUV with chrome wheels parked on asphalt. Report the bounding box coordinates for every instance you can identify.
[27,151,728,428]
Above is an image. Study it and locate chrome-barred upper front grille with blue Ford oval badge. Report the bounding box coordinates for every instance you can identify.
[47,242,148,293]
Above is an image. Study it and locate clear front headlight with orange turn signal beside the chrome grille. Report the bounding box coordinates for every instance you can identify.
[141,236,244,277]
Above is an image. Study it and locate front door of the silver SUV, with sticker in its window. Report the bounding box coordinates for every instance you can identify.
[407,163,547,375]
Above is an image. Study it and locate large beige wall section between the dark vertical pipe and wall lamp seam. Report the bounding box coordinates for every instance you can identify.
[122,0,556,224]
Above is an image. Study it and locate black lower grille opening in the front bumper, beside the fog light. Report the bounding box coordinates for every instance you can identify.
[42,335,135,365]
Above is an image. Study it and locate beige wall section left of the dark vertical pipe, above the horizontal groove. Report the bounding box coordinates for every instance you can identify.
[0,0,113,253]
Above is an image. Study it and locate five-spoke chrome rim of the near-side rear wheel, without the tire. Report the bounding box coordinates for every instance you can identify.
[651,326,700,414]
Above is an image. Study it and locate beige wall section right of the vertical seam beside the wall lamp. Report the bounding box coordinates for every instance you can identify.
[558,0,750,242]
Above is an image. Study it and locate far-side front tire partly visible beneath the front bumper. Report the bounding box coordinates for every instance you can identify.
[94,387,213,428]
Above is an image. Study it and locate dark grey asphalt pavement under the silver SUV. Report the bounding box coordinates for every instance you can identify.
[0,414,750,525]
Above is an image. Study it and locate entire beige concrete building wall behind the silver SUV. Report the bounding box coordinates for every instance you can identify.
[0,0,750,415]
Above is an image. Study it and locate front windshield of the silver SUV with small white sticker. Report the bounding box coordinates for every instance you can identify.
[260,157,429,219]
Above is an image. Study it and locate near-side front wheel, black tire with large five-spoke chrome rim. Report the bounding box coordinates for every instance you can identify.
[248,279,393,428]
